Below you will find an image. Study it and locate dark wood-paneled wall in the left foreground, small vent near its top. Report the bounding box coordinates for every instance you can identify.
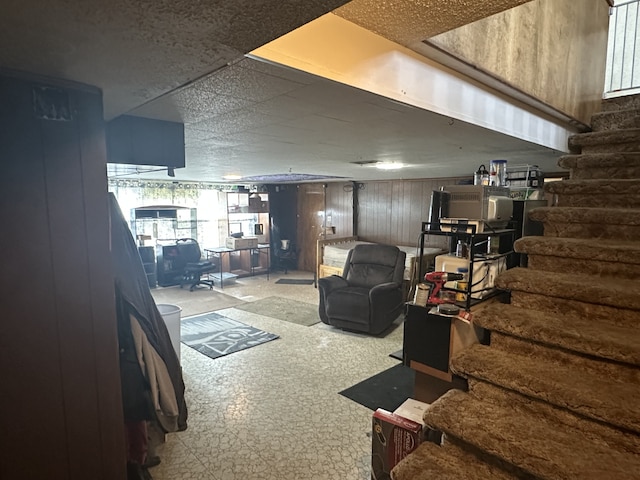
[0,76,126,480]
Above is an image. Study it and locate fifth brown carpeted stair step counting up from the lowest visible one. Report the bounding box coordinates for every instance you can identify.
[495,267,640,315]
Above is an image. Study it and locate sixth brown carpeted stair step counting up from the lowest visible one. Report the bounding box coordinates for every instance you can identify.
[514,237,640,281]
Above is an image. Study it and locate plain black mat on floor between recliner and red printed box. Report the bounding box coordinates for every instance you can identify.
[339,365,415,412]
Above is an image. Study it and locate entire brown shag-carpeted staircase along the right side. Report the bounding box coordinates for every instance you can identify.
[392,95,640,480]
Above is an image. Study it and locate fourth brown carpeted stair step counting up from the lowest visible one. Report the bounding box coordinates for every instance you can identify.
[473,304,640,367]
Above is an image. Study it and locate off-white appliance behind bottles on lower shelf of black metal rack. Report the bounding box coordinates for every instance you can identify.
[435,254,507,299]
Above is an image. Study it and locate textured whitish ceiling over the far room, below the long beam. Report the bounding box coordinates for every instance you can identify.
[126,58,560,181]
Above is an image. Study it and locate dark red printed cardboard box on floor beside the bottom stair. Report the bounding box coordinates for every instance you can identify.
[371,408,422,480]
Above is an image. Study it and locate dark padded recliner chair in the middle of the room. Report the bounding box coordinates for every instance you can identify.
[318,244,406,335]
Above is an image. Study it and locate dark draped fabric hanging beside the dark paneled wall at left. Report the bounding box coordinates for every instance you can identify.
[109,193,187,432]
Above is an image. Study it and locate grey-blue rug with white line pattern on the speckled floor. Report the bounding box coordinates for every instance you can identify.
[180,312,279,358]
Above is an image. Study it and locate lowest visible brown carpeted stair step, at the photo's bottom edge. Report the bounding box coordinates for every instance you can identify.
[391,442,523,480]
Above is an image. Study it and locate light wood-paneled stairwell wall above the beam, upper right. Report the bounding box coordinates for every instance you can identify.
[427,0,609,125]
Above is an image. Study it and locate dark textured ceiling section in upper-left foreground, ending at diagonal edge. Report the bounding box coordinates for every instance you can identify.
[0,0,345,118]
